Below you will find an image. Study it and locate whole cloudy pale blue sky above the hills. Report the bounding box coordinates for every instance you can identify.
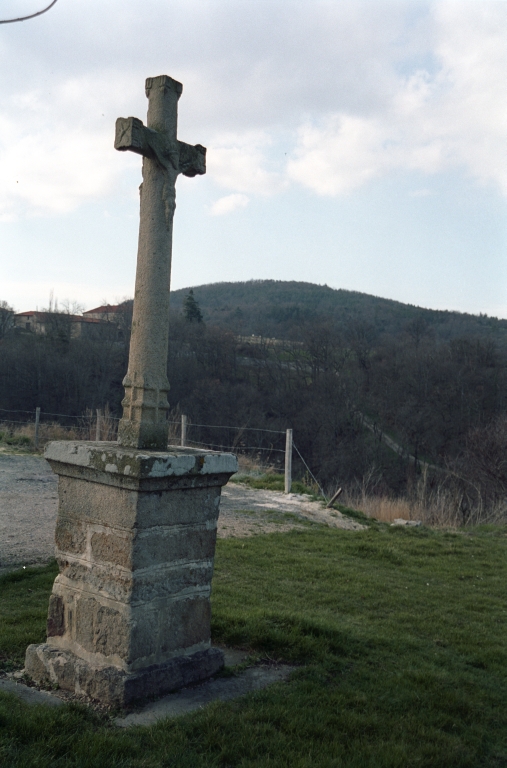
[0,0,507,318]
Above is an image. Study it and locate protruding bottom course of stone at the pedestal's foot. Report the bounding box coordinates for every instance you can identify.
[25,643,224,707]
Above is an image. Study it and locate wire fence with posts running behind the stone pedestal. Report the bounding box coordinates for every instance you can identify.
[0,406,325,497]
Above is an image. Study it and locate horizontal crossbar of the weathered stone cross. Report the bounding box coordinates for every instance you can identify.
[114,117,206,176]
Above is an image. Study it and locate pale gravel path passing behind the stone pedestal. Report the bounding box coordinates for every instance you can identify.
[0,453,363,573]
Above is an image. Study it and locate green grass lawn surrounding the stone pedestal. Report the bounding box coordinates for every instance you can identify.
[0,524,507,768]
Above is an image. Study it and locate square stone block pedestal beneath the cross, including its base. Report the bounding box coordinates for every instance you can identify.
[25,442,237,706]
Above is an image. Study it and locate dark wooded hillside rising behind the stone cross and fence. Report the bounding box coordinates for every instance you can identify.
[0,281,507,516]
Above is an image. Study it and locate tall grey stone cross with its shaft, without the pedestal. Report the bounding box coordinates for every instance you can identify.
[114,75,206,450]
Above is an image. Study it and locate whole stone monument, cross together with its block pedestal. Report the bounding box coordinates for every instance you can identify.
[25,76,238,707]
